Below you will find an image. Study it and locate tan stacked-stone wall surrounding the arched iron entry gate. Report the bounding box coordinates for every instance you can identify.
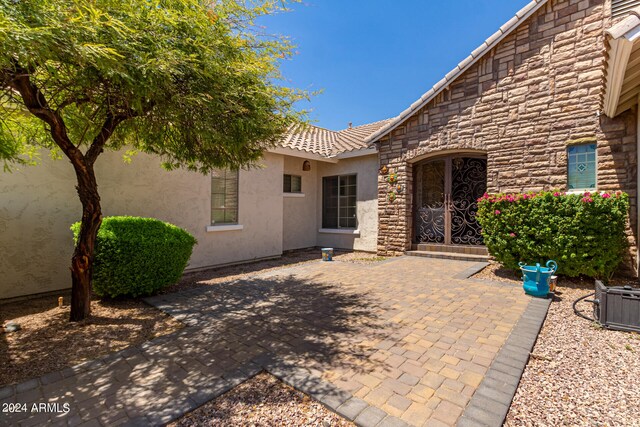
[378,0,637,265]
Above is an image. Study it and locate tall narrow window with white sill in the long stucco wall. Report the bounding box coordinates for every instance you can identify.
[211,169,238,225]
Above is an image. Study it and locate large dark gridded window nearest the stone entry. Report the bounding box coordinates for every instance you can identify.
[322,175,357,228]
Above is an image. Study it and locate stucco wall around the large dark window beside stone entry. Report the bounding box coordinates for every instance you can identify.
[317,155,378,252]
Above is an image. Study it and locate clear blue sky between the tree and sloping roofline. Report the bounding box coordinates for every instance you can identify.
[260,0,529,130]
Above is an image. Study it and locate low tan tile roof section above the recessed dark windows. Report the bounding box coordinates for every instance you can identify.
[280,119,392,157]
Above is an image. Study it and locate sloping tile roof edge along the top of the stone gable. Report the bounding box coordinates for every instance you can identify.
[365,0,548,144]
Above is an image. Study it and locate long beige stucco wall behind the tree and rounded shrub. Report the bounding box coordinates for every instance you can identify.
[0,152,284,298]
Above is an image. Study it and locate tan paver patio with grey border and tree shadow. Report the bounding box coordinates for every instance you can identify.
[0,257,548,425]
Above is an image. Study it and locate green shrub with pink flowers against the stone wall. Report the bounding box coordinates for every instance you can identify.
[477,191,629,279]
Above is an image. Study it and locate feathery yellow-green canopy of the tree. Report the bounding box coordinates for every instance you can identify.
[0,0,306,172]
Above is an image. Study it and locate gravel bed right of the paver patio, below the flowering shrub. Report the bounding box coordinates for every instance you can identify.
[476,264,640,426]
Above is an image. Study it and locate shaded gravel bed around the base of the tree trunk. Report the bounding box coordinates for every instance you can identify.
[0,293,182,386]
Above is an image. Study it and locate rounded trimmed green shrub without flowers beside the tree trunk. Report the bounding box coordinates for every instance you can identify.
[71,216,197,298]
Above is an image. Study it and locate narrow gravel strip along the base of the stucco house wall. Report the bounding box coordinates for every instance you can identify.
[161,249,386,294]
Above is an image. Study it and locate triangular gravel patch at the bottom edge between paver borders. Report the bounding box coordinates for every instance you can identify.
[169,372,354,427]
